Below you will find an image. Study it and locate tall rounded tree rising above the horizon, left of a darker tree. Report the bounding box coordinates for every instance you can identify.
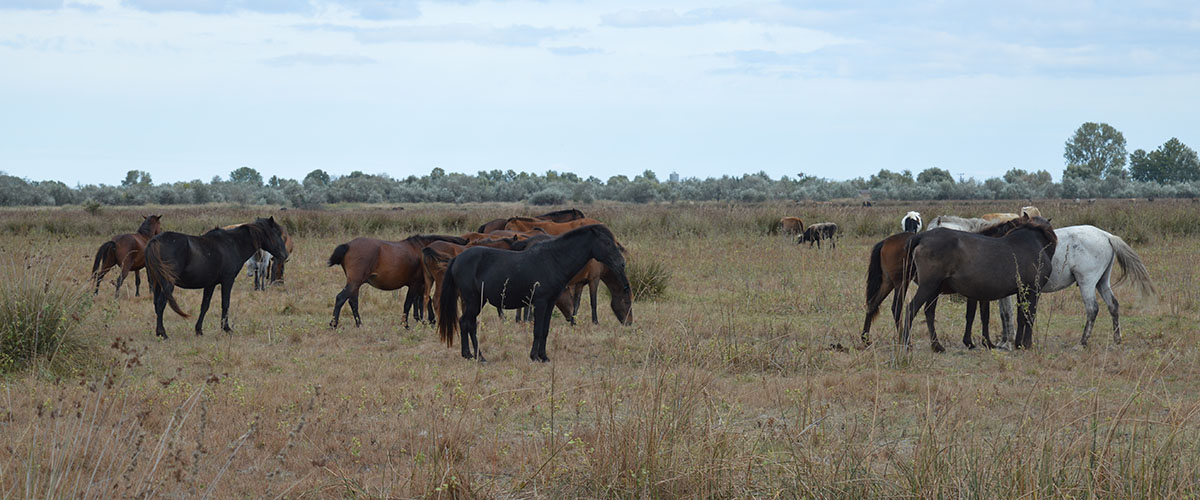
[1062,121,1128,180]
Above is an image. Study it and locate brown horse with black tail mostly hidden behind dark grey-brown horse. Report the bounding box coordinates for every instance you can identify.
[862,215,1016,349]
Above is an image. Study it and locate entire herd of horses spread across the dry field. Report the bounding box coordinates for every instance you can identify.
[92,206,1153,362]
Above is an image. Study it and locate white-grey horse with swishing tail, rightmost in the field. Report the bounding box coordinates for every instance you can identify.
[1000,225,1154,347]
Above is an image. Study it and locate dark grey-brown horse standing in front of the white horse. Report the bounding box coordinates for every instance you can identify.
[898,216,1058,353]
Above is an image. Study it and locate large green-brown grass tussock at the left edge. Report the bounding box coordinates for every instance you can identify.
[0,257,91,373]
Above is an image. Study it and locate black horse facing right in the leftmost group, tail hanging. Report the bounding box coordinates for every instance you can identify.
[145,217,288,338]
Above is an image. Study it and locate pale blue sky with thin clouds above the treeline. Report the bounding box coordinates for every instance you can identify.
[0,0,1200,186]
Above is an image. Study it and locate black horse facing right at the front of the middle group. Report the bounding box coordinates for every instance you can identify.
[438,224,630,362]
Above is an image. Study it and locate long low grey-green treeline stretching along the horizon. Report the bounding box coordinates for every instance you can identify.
[0,167,1200,209]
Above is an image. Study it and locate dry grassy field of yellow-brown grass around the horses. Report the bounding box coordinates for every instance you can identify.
[0,200,1200,499]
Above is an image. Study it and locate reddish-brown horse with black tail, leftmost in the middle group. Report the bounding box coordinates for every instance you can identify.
[328,234,467,329]
